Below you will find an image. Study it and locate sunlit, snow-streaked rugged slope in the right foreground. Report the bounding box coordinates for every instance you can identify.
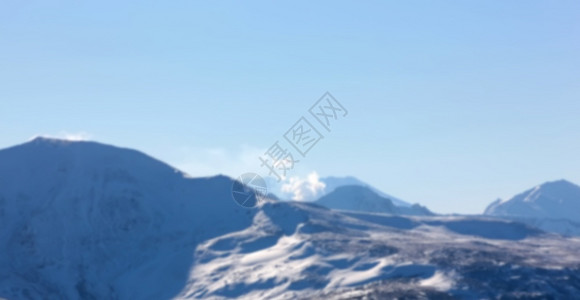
[185,202,580,299]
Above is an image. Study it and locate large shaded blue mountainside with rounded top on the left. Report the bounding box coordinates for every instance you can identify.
[0,138,253,299]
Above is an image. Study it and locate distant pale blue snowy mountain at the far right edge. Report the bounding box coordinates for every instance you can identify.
[484,180,580,235]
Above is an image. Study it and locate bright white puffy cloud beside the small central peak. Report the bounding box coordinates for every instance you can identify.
[282,172,326,201]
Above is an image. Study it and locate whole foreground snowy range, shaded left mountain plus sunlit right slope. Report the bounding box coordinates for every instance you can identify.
[0,138,580,299]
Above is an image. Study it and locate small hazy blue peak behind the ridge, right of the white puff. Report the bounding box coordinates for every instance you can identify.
[314,185,433,216]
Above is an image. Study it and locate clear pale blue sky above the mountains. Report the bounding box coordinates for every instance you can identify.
[0,0,580,213]
